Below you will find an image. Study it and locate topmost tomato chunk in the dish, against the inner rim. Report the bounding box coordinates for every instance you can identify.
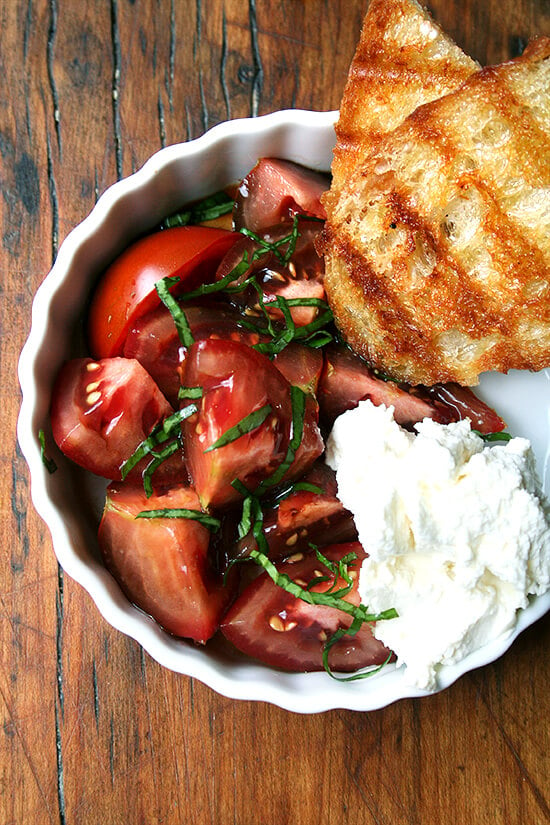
[233,158,329,232]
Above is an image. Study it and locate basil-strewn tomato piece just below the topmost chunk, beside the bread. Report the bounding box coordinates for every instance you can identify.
[216,219,325,326]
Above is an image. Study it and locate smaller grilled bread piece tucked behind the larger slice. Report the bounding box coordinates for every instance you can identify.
[325,0,479,210]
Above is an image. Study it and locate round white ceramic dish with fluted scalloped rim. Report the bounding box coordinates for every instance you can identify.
[18,111,550,713]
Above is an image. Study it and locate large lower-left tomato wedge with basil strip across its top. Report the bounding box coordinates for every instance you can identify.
[99,483,233,643]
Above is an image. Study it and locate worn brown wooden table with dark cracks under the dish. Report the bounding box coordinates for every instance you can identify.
[4,0,550,825]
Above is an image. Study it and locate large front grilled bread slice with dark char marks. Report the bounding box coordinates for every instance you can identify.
[323,38,550,385]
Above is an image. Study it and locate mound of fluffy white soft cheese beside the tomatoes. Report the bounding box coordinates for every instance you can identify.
[326,401,550,689]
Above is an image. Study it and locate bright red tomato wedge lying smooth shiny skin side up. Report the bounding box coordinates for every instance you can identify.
[88,226,240,358]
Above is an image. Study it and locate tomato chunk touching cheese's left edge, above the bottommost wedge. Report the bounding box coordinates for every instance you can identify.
[236,461,357,559]
